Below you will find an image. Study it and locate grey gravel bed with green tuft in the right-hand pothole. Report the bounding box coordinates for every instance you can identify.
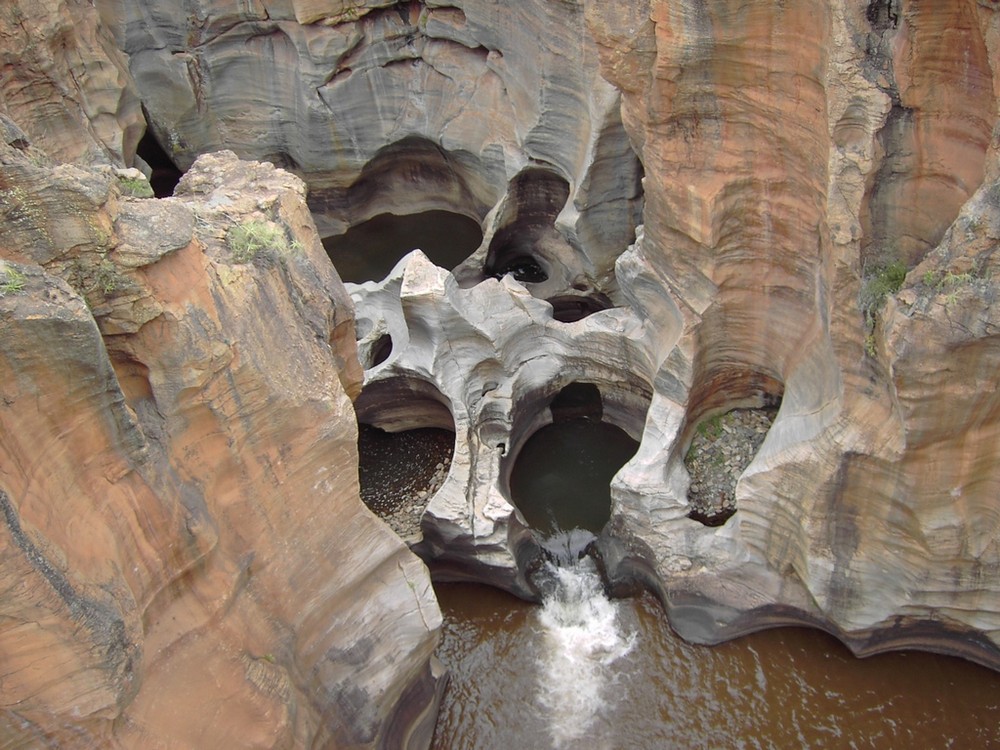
[684,409,778,526]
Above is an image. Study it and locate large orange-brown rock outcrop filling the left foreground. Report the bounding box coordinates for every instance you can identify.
[0,125,440,748]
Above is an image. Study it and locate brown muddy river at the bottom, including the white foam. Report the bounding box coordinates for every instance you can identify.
[433,573,1000,750]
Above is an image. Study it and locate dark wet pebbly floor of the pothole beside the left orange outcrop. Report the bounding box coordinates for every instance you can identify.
[358,424,455,541]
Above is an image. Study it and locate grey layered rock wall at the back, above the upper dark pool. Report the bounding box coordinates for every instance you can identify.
[115,1,642,304]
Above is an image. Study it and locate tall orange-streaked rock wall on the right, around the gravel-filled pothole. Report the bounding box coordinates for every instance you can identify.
[589,2,1000,664]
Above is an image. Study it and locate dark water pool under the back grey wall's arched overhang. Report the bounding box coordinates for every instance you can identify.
[323,211,483,284]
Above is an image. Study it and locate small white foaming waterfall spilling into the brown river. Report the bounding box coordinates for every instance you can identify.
[538,529,636,748]
